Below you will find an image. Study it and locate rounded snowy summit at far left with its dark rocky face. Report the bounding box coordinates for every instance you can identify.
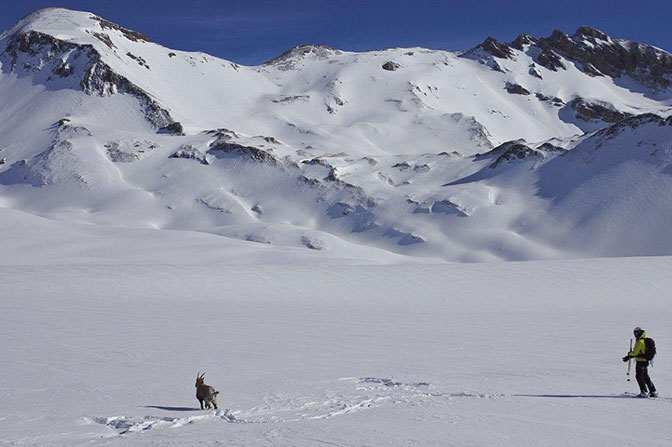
[0,8,174,128]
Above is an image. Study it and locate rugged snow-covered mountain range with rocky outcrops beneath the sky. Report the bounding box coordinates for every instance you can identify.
[0,8,672,261]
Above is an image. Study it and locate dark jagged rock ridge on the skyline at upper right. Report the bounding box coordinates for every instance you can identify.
[464,27,672,92]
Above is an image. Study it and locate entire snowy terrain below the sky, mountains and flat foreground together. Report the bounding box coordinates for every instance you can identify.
[0,8,672,447]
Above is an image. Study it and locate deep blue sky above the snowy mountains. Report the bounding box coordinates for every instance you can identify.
[0,0,672,64]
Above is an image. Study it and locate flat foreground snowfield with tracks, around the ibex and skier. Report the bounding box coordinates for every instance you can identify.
[0,257,672,447]
